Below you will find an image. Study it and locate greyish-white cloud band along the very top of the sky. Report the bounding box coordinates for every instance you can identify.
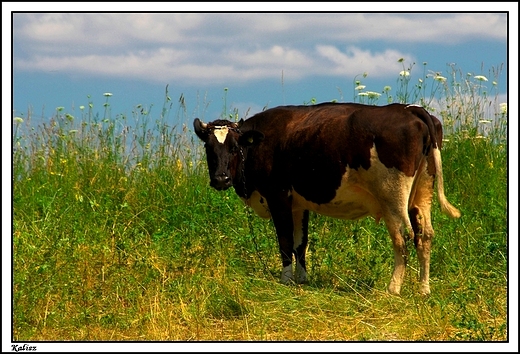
[13,13,507,45]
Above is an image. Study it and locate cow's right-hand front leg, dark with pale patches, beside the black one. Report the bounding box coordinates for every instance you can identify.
[293,209,309,284]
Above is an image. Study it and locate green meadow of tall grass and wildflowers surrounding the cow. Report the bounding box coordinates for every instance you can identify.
[12,63,509,341]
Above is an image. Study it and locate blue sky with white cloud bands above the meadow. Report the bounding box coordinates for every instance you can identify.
[6,3,508,129]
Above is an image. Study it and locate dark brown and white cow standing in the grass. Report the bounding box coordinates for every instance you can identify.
[193,103,461,295]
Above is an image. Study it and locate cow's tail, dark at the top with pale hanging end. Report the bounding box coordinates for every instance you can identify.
[405,105,461,218]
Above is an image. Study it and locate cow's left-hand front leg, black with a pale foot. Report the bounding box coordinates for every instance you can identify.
[266,192,294,284]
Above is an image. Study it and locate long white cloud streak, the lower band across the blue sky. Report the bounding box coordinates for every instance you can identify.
[15,45,413,85]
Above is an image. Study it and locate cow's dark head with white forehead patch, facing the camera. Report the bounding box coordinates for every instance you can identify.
[193,118,264,190]
